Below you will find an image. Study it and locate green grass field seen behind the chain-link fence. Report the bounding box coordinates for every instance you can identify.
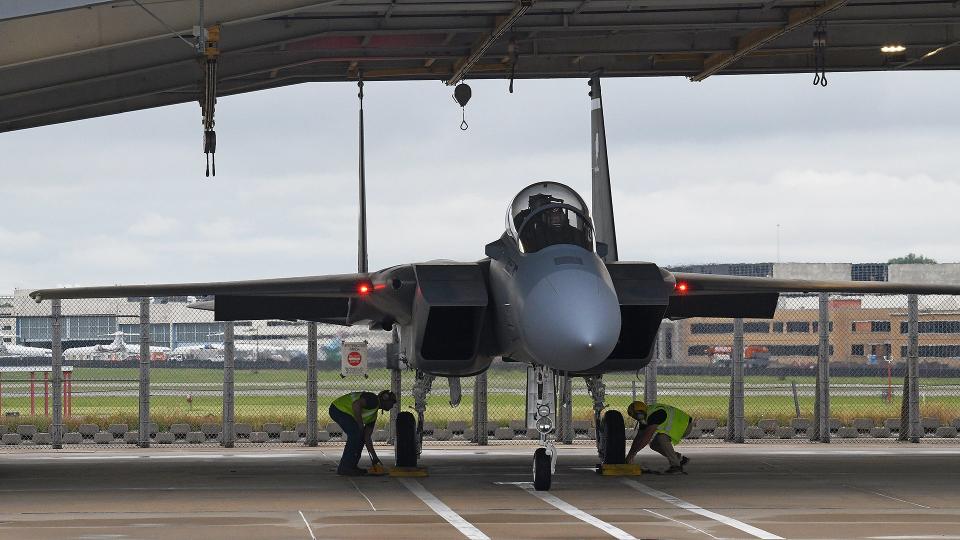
[0,367,960,429]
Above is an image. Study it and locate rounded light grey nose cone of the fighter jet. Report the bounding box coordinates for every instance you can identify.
[521,270,620,371]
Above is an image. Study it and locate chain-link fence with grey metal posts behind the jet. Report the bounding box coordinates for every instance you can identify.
[0,295,960,447]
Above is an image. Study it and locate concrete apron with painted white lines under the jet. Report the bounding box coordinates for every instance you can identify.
[0,443,960,540]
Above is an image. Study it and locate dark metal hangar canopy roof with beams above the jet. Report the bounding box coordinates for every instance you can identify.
[0,0,960,131]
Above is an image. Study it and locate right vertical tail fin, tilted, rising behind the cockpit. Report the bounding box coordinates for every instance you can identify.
[590,74,619,262]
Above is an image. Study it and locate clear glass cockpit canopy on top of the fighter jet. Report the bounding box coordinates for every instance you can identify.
[507,182,593,253]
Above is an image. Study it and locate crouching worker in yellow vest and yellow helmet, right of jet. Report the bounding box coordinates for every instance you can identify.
[627,401,693,474]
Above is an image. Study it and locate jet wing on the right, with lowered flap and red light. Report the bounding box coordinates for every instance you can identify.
[664,272,960,319]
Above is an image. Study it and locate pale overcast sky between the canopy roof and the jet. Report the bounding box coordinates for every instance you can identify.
[0,72,960,294]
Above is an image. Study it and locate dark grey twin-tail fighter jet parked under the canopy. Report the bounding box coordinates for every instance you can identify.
[31,79,960,489]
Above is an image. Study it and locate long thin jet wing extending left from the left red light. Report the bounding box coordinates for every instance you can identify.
[30,273,372,302]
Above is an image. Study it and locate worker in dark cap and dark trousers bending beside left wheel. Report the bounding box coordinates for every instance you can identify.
[330,390,397,476]
